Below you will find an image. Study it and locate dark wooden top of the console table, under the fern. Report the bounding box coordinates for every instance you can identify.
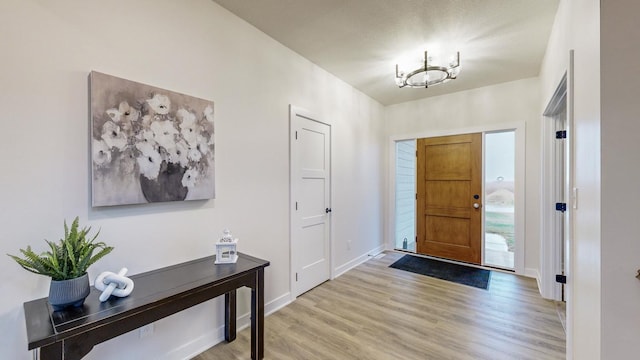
[24,253,269,350]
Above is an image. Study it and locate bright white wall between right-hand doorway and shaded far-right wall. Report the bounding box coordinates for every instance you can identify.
[540,0,604,360]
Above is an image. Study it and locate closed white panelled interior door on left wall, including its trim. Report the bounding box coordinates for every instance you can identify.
[290,106,331,298]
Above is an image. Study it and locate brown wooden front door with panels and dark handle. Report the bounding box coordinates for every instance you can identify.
[416,133,482,264]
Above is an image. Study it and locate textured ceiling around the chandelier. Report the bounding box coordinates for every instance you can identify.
[214,0,559,105]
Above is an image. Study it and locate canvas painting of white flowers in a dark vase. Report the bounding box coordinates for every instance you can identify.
[90,71,215,206]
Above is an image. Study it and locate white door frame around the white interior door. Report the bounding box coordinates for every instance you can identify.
[289,104,335,301]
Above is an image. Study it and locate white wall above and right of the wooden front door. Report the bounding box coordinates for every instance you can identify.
[386,78,541,276]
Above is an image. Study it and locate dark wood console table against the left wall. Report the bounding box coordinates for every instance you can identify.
[24,253,269,360]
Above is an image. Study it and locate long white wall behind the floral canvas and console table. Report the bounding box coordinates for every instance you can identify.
[0,0,385,360]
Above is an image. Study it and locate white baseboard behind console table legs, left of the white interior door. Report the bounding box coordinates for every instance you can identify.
[178,293,291,360]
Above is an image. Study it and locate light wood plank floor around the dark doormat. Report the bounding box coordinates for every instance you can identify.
[194,253,565,360]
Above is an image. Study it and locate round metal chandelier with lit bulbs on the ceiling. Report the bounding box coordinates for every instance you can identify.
[396,51,460,88]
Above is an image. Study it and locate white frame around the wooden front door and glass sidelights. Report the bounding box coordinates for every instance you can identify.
[386,121,524,278]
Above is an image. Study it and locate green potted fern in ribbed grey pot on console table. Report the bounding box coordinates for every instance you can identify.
[7,217,113,311]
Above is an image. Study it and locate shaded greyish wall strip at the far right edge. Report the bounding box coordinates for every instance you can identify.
[600,0,640,359]
